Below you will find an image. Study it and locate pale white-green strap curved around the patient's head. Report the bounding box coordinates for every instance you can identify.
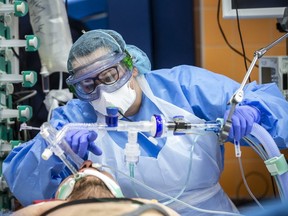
[55,168,124,200]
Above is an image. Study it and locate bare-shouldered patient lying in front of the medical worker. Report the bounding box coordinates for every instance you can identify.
[12,161,178,216]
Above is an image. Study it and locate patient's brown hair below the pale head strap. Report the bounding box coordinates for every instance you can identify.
[67,176,114,201]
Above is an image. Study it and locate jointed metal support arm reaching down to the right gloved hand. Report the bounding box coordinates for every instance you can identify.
[219,33,288,143]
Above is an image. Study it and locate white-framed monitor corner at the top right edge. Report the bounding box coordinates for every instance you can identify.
[222,0,288,19]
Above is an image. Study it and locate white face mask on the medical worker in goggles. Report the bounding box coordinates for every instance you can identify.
[90,82,136,115]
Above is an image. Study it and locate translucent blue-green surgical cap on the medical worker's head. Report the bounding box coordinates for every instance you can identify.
[67,29,151,75]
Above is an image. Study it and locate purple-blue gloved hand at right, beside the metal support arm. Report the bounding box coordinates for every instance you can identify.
[224,105,261,141]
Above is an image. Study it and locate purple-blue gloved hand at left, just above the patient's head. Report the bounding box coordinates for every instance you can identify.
[65,130,102,158]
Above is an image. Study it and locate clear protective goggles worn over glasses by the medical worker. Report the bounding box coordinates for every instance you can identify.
[66,52,133,101]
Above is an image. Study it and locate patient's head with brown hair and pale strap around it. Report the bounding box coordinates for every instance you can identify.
[56,167,124,201]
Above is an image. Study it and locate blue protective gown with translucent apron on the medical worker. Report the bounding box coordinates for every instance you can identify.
[3,65,288,215]
